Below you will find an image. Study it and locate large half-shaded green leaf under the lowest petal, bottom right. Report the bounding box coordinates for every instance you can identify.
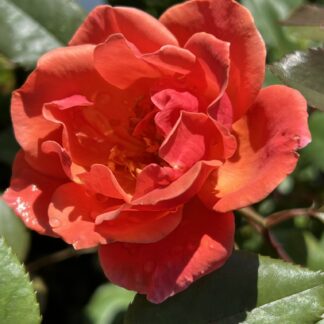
[126,252,324,324]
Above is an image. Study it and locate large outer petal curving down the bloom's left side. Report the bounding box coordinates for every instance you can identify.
[11,45,106,178]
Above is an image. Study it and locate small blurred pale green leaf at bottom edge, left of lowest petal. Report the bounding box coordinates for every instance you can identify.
[86,284,135,324]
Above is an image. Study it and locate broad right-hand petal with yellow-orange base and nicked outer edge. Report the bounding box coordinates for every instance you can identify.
[200,86,310,212]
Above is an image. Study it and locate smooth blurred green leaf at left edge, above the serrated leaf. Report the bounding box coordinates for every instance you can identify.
[0,199,30,261]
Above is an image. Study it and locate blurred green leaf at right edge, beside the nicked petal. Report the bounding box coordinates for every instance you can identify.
[301,111,324,171]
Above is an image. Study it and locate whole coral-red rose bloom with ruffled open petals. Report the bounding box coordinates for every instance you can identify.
[5,0,310,303]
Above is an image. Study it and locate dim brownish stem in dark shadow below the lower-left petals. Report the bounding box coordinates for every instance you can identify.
[26,248,95,272]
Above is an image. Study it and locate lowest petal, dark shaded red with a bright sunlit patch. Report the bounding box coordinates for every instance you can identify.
[99,200,234,303]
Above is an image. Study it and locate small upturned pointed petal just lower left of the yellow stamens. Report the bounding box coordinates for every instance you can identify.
[78,164,131,202]
